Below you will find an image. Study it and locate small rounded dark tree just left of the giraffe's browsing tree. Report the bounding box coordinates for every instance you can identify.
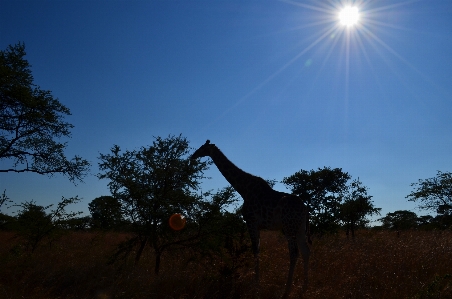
[88,196,123,229]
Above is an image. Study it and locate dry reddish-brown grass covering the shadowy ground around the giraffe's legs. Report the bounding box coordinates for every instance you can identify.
[0,231,452,299]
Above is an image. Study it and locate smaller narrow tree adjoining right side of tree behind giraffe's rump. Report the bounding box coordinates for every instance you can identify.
[340,179,381,237]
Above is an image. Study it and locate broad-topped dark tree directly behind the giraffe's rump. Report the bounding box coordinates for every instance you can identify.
[283,167,351,232]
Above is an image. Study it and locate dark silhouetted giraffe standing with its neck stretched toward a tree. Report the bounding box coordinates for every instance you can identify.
[191,140,312,298]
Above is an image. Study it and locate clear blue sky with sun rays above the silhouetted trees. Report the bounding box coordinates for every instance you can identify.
[0,0,452,220]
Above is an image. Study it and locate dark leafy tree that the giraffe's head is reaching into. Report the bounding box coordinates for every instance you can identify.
[98,135,208,273]
